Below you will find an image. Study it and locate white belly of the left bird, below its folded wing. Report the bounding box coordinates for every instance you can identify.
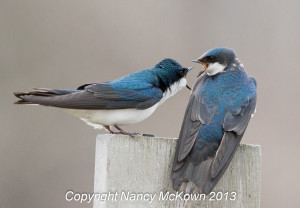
[63,103,158,128]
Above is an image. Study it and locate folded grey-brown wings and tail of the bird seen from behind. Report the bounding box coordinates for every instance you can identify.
[172,77,256,194]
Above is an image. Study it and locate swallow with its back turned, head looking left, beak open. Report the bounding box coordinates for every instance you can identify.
[172,48,256,194]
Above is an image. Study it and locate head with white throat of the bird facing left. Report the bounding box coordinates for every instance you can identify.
[193,48,236,76]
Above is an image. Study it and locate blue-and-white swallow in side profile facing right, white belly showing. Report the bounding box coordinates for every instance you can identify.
[14,59,192,135]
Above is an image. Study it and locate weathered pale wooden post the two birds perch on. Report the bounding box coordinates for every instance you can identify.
[94,134,261,208]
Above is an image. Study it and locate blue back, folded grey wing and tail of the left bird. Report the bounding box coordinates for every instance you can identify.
[16,70,163,110]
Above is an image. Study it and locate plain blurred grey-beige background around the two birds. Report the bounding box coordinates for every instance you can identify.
[0,0,300,208]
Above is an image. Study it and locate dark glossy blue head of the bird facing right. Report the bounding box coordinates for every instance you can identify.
[152,58,192,91]
